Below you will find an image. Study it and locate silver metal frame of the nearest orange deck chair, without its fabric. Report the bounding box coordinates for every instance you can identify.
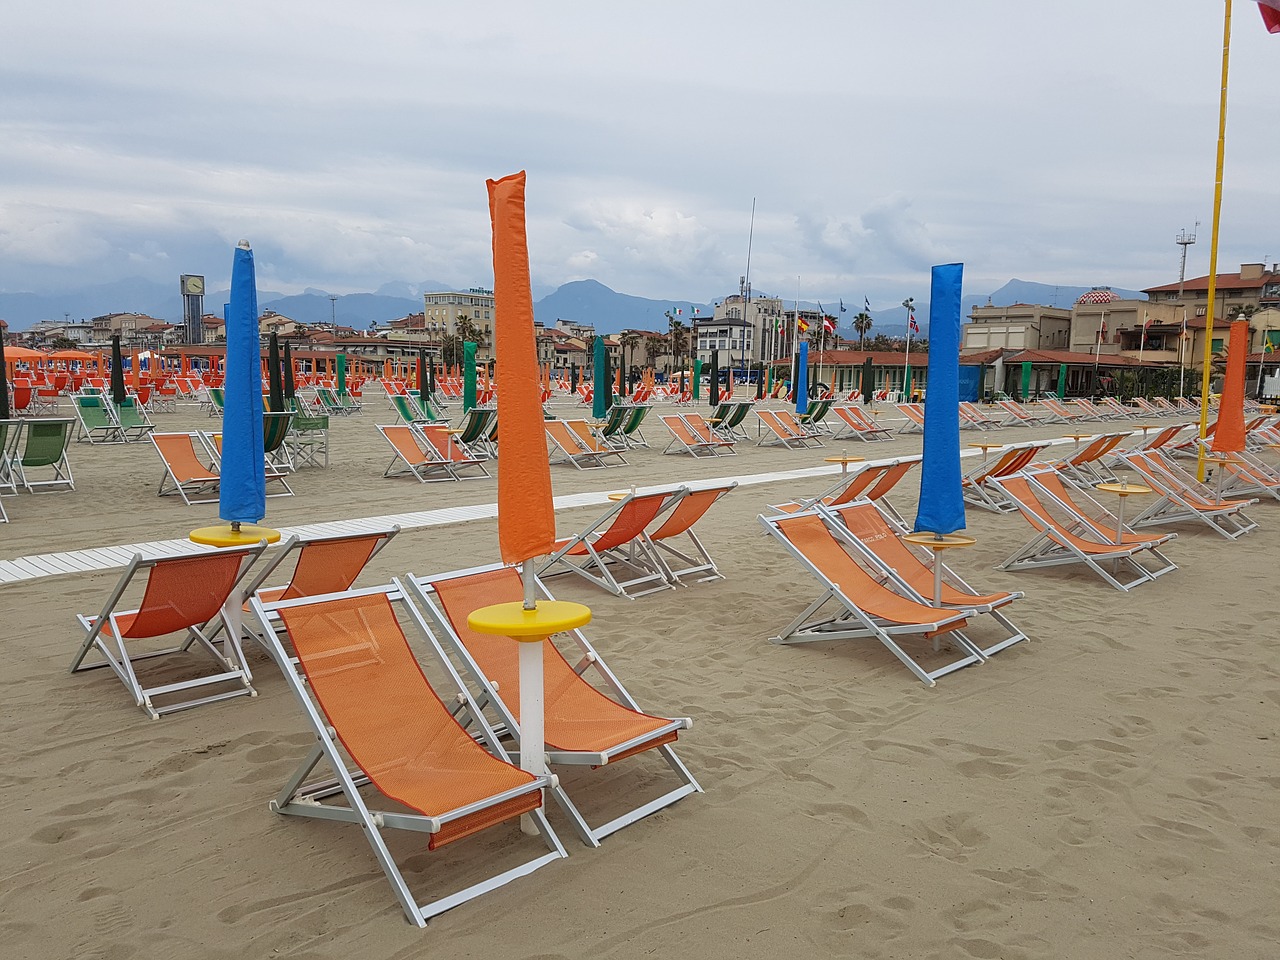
[251,582,568,927]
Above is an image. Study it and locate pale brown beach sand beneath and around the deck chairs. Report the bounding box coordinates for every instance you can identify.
[0,403,1280,960]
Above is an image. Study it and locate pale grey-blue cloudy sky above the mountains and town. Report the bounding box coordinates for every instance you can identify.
[0,0,1280,307]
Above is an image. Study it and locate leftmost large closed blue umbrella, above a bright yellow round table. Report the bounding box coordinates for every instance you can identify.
[218,241,266,525]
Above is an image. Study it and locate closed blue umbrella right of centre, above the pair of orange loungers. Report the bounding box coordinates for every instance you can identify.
[915,264,964,536]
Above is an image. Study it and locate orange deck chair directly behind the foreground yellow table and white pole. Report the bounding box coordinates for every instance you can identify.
[410,567,701,846]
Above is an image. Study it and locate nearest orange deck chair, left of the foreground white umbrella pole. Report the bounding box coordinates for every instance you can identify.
[252,584,567,927]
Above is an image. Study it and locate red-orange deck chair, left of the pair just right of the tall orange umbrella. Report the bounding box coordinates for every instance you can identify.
[538,486,687,599]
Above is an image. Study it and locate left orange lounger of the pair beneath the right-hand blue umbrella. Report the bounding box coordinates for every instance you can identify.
[759,511,987,686]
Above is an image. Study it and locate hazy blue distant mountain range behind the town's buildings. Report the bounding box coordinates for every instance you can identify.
[0,278,1143,337]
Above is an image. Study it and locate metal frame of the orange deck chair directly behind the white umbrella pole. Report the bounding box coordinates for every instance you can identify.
[407,564,703,846]
